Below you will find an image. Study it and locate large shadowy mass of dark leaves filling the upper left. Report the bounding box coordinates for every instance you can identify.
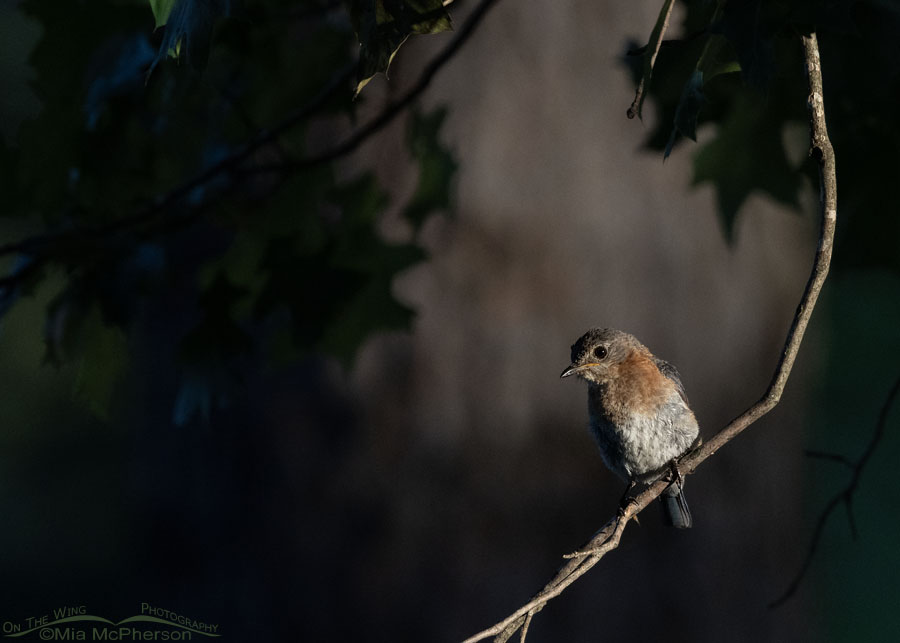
[0,0,456,424]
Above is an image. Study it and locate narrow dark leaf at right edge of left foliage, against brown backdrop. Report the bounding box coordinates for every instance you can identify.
[404,107,459,230]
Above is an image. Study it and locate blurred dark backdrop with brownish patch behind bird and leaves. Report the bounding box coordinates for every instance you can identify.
[0,1,900,642]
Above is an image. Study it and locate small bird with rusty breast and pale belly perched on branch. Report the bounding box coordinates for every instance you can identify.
[560,328,700,529]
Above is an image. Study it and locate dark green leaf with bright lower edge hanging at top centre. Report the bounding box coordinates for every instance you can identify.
[349,0,453,95]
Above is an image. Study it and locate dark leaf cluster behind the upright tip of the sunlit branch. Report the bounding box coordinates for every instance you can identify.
[626,0,900,254]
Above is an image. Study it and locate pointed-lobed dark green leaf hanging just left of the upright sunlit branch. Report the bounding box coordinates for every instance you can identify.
[694,96,800,241]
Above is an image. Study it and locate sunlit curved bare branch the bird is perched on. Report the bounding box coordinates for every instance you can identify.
[465,28,836,643]
